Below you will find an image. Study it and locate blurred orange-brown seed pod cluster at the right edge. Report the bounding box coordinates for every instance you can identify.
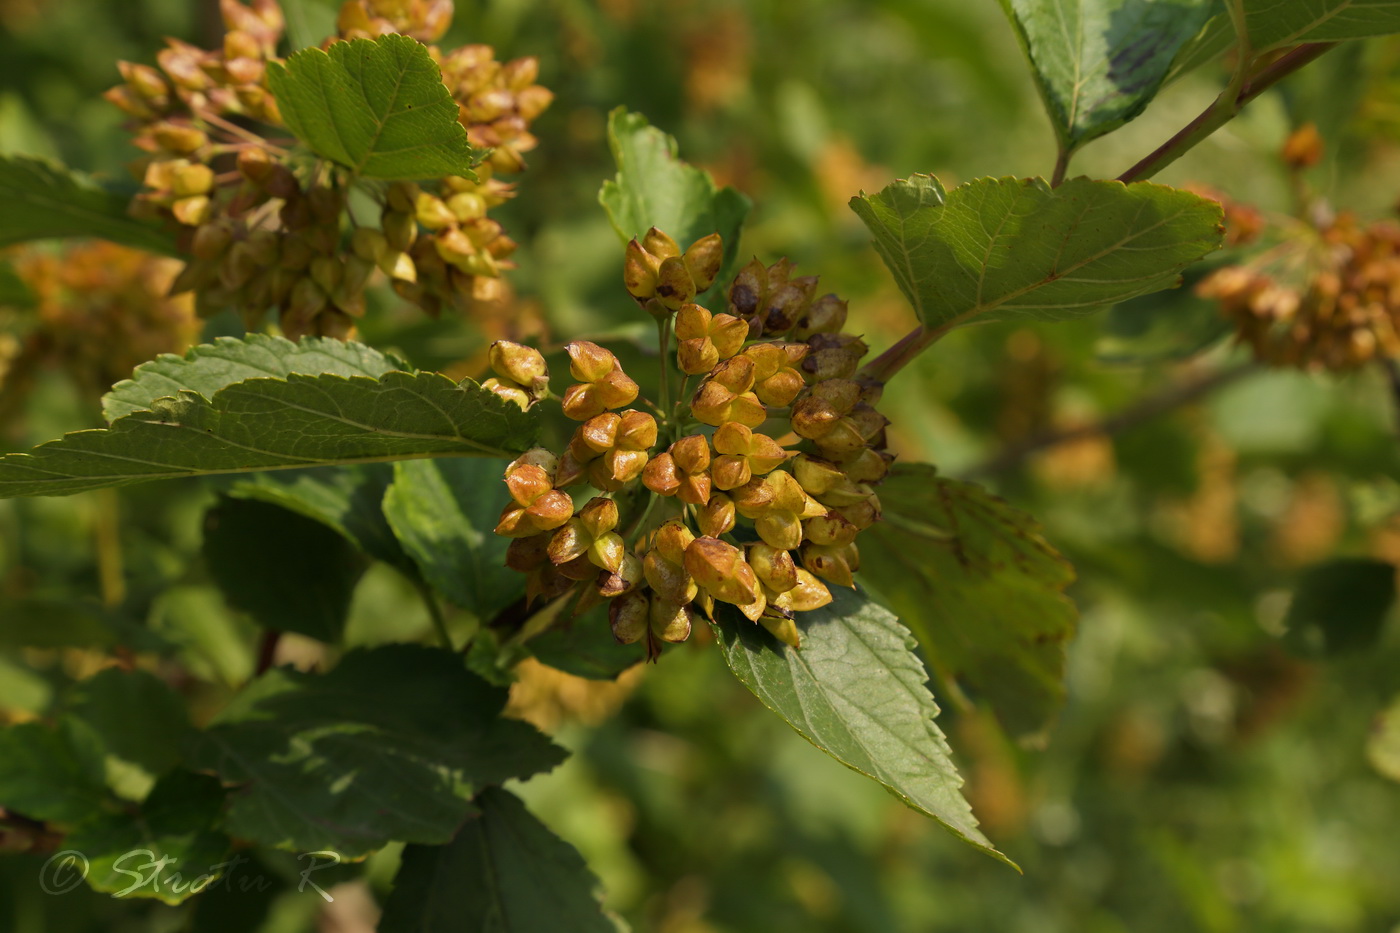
[1197,214,1400,371]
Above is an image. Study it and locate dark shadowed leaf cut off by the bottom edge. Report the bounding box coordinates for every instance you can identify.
[378,789,623,933]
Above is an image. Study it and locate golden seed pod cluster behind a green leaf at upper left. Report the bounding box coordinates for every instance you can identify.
[106,0,553,338]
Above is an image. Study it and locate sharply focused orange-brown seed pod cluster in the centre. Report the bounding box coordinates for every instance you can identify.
[493,230,892,658]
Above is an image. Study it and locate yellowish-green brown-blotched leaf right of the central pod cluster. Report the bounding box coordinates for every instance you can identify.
[861,464,1075,733]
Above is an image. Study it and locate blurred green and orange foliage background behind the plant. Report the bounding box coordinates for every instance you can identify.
[0,0,1400,933]
